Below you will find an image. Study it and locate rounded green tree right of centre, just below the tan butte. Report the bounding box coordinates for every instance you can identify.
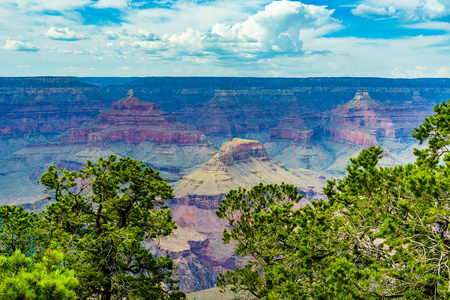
[216,184,368,299]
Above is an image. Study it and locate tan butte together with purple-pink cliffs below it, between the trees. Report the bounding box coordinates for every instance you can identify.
[167,138,325,291]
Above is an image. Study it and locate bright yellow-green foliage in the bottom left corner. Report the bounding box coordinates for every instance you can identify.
[0,250,78,300]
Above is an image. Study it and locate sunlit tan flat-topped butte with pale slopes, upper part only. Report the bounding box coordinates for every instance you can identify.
[174,138,324,208]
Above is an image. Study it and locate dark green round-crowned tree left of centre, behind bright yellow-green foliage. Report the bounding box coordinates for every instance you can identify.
[40,156,185,300]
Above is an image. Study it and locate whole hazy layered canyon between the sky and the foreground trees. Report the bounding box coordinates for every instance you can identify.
[0,77,450,292]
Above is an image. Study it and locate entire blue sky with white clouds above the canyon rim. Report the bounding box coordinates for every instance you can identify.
[0,0,450,78]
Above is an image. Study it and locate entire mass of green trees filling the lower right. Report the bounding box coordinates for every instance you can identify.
[217,102,450,299]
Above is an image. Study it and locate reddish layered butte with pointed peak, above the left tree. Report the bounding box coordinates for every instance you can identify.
[50,90,216,176]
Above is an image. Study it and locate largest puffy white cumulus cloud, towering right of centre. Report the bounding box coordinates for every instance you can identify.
[125,0,343,61]
